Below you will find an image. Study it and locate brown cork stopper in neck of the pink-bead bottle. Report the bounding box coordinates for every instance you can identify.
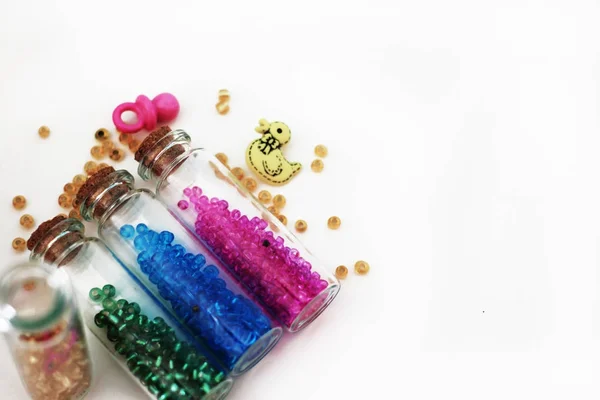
[135,125,185,177]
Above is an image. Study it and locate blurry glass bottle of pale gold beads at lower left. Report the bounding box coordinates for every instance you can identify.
[0,264,92,400]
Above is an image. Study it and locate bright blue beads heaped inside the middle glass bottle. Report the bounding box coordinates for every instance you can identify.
[120,224,272,369]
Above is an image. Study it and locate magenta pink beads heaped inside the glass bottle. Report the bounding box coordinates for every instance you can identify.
[178,186,329,326]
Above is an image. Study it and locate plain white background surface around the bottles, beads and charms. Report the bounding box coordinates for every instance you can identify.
[0,0,600,400]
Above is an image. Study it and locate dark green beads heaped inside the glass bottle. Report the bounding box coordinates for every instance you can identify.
[89,285,225,400]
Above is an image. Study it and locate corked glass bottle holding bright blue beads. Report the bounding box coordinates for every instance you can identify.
[77,167,283,376]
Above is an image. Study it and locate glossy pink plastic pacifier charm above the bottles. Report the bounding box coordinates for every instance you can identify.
[113,93,179,133]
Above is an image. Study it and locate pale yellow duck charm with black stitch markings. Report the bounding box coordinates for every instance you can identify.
[246,119,302,185]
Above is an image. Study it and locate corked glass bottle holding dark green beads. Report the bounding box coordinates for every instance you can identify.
[28,216,232,400]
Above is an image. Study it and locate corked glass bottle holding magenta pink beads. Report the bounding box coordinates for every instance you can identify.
[136,127,340,332]
